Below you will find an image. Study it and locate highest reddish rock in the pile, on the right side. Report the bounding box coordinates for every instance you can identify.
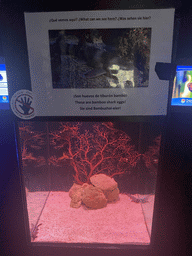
[90,173,119,202]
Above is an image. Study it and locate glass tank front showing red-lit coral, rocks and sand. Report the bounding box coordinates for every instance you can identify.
[19,121,162,245]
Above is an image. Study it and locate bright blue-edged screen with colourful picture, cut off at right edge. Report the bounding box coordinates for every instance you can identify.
[171,66,192,106]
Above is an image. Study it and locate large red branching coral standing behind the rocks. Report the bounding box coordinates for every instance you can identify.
[51,122,140,184]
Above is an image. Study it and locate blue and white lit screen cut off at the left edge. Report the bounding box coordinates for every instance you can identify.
[0,64,9,109]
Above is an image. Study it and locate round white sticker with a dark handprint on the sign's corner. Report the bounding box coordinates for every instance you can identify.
[10,90,35,119]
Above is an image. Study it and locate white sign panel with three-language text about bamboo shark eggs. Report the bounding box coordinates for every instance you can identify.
[25,9,174,116]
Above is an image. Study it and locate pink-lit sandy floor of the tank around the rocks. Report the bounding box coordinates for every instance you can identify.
[27,192,154,244]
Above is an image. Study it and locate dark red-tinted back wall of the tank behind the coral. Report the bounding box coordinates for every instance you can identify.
[19,121,162,194]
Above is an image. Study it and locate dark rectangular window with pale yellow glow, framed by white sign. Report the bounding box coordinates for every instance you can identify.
[49,28,151,89]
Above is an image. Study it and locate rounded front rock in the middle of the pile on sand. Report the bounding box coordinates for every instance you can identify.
[82,185,107,209]
